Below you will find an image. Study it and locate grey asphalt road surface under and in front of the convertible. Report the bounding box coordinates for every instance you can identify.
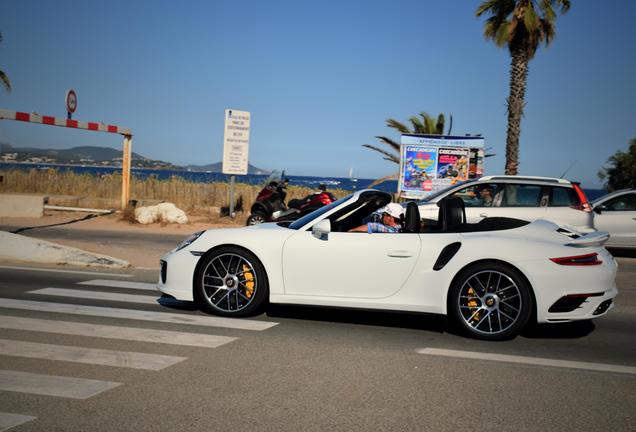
[0,258,636,432]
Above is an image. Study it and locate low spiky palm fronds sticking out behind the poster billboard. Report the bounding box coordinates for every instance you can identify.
[362,112,453,187]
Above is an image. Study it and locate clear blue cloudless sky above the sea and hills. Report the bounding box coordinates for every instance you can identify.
[0,0,636,188]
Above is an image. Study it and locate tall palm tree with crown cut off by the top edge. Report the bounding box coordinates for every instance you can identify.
[476,0,570,175]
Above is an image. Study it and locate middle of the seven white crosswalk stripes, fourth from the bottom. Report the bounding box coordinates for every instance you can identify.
[0,315,236,348]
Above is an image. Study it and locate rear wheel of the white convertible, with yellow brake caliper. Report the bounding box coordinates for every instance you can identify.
[448,262,532,340]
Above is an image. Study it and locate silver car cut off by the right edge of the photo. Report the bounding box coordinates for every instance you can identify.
[592,189,636,249]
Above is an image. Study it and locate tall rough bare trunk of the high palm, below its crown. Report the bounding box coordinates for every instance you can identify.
[506,48,530,175]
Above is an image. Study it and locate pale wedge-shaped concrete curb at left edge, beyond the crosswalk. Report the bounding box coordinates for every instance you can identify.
[0,231,130,268]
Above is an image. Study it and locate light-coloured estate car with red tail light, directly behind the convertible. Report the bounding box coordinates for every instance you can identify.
[417,175,594,233]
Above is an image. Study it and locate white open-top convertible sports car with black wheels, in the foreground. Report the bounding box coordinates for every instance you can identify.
[157,190,618,340]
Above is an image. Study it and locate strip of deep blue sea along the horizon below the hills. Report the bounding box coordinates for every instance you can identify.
[0,162,607,201]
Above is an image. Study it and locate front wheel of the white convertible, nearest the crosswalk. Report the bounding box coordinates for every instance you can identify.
[195,246,269,317]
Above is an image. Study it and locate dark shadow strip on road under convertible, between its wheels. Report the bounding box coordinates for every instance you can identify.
[267,304,447,333]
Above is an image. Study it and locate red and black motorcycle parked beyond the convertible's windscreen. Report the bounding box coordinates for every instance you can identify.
[247,172,336,225]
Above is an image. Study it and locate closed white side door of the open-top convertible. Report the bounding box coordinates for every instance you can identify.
[282,231,420,299]
